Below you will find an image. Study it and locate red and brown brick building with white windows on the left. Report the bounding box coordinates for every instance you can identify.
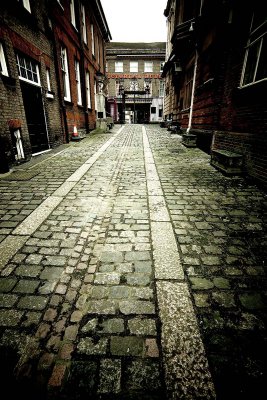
[0,0,111,172]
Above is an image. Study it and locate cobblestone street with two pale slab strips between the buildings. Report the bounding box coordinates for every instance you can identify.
[0,124,267,400]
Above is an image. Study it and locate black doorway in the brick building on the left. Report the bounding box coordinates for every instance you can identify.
[20,81,49,154]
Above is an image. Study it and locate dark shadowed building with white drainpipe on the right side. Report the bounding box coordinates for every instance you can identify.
[163,0,267,183]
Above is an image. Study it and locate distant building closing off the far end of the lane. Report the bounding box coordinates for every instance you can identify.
[107,42,166,123]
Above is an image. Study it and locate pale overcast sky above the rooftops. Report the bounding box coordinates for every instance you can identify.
[100,0,167,42]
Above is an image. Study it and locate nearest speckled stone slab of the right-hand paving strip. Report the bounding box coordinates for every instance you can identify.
[156,281,216,400]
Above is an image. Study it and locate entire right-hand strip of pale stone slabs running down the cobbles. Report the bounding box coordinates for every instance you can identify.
[142,127,216,400]
